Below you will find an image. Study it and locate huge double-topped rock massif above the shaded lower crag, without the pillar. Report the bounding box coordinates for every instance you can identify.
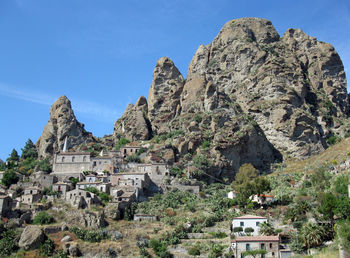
[180,18,348,158]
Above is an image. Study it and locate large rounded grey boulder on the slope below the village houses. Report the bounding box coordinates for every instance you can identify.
[18,226,46,250]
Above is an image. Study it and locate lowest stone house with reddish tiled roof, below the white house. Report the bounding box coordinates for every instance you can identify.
[231,236,280,258]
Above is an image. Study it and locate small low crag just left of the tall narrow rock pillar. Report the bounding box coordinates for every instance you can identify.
[114,96,152,141]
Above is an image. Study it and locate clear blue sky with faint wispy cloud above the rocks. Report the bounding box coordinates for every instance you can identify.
[0,0,350,160]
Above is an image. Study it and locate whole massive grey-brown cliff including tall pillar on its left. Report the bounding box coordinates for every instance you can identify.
[113,18,349,175]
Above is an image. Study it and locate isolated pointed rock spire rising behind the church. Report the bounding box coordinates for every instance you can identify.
[36,96,92,158]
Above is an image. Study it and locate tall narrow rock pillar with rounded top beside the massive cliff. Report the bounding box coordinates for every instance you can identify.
[148,57,184,133]
